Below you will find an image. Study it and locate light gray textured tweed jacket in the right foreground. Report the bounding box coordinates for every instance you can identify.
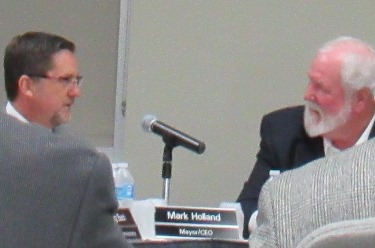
[249,139,375,248]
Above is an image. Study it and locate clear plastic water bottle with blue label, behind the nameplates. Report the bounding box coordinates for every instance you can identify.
[113,163,134,208]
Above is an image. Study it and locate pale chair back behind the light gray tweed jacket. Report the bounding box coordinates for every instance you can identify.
[297,217,375,248]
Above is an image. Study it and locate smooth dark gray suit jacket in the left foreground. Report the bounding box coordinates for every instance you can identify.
[0,113,131,248]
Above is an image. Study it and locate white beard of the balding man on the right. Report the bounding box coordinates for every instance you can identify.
[304,100,351,137]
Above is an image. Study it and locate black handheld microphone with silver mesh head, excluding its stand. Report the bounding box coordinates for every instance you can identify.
[142,115,206,154]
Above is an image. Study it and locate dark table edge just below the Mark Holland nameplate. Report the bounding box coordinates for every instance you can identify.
[132,239,249,248]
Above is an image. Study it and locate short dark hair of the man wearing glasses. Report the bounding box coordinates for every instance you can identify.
[3,32,75,101]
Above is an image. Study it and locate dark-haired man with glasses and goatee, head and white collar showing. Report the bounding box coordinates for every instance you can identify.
[4,32,82,129]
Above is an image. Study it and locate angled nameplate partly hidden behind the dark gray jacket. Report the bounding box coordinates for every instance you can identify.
[113,208,142,240]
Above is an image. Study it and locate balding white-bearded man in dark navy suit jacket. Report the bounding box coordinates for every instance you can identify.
[237,37,375,238]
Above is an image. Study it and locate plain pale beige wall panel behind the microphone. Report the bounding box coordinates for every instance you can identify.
[124,0,375,206]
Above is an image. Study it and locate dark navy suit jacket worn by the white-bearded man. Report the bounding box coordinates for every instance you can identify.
[237,106,375,238]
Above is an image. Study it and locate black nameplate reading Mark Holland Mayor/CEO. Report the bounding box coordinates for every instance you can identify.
[155,207,239,240]
